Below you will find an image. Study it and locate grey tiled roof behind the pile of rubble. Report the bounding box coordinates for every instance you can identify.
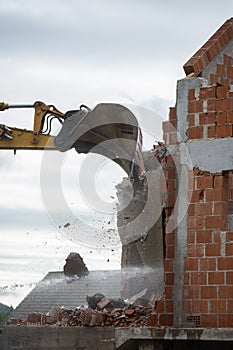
[10,270,121,319]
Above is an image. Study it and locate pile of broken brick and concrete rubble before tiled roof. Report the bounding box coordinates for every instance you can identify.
[8,295,154,327]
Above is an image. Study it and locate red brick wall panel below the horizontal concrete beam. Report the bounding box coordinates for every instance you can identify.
[183,169,233,327]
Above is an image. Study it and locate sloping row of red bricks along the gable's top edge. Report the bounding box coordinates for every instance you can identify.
[183,18,233,76]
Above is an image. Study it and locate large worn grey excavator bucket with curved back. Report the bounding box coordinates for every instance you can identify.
[54,103,144,179]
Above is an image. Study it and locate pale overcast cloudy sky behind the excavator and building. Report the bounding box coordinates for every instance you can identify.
[0,0,233,306]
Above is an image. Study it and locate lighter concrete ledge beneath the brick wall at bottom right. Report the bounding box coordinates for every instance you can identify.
[115,327,233,348]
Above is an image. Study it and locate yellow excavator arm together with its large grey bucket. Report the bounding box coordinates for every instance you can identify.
[0,101,144,180]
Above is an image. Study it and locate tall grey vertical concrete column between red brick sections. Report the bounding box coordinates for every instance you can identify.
[172,78,207,326]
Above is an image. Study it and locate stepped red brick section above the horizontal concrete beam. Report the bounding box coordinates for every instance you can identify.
[188,55,233,139]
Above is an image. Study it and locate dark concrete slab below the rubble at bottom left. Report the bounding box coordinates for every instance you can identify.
[0,326,116,350]
